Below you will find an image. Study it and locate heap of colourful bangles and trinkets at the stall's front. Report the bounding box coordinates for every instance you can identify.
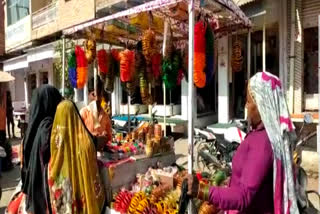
[112,167,226,214]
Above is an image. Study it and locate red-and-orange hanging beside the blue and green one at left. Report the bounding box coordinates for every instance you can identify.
[75,45,88,89]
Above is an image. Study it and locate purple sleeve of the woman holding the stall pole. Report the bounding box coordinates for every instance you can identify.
[209,138,273,211]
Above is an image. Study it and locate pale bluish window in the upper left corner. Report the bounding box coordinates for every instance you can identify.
[7,0,30,26]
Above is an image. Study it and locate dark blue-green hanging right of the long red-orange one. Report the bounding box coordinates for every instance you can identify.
[205,21,214,85]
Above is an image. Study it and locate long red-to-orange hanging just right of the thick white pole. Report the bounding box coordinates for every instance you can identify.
[193,21,207,88]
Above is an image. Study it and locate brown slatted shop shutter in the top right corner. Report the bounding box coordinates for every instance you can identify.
[302,0,320,28]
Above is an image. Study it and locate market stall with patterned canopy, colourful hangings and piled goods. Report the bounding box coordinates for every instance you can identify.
[63,0,251,213]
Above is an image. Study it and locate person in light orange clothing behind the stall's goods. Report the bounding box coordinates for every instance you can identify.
[80,78,112,141]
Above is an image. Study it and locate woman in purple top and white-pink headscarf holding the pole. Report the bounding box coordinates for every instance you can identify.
[188,72,299,214]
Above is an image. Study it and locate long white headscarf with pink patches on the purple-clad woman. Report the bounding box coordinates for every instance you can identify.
[249,72,299,214]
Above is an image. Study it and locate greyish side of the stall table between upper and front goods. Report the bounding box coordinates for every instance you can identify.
[99,152,176,202]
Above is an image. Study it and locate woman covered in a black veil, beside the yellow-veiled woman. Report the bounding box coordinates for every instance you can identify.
[21,85,62,214]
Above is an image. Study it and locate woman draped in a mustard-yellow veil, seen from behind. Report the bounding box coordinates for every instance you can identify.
[48,101,105,214]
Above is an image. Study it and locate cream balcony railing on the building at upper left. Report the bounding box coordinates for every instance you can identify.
[32,2,57,29]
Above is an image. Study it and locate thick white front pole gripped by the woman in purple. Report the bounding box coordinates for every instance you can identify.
[188,0,195,214]
